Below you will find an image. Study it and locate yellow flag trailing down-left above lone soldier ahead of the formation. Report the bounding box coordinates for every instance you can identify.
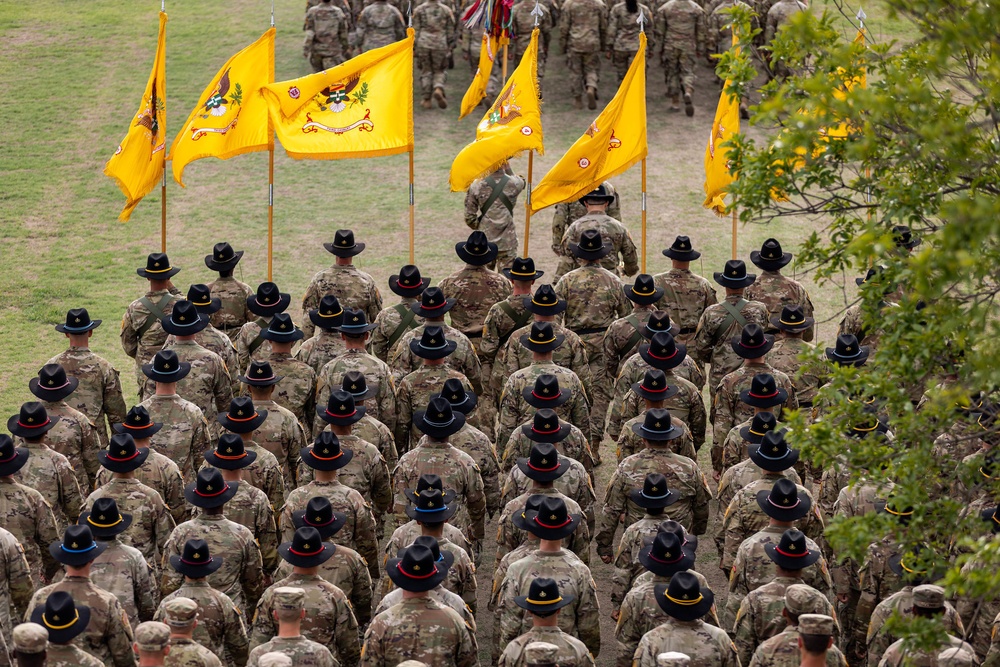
[531,33,647,213]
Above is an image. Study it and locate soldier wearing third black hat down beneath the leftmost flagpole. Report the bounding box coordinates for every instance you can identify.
[138,350,209,481]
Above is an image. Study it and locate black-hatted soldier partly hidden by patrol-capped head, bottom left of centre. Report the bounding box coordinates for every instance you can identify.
[250,527,361,665]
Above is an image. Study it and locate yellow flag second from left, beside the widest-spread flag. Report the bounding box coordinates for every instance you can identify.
[170,28,274,186]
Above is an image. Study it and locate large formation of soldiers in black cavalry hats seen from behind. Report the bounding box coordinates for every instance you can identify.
[0,202,1000,667]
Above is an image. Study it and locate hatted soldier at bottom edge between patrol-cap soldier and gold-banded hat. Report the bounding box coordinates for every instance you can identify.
[359,544,479,667]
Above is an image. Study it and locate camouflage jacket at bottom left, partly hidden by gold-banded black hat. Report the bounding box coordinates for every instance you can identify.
[24,577,138,667]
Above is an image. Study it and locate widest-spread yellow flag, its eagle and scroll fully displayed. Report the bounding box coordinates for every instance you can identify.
[260,28,413,160]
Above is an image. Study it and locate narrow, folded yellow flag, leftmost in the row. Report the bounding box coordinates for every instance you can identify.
[104,12,167,222]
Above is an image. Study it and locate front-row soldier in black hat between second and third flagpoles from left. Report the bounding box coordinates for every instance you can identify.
[302,232,380,338]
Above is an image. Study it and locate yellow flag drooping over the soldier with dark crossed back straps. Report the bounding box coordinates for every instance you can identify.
[450,28,545,192]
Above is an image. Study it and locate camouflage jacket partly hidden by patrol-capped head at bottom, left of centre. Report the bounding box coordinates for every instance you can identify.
[250,574,361,665]
